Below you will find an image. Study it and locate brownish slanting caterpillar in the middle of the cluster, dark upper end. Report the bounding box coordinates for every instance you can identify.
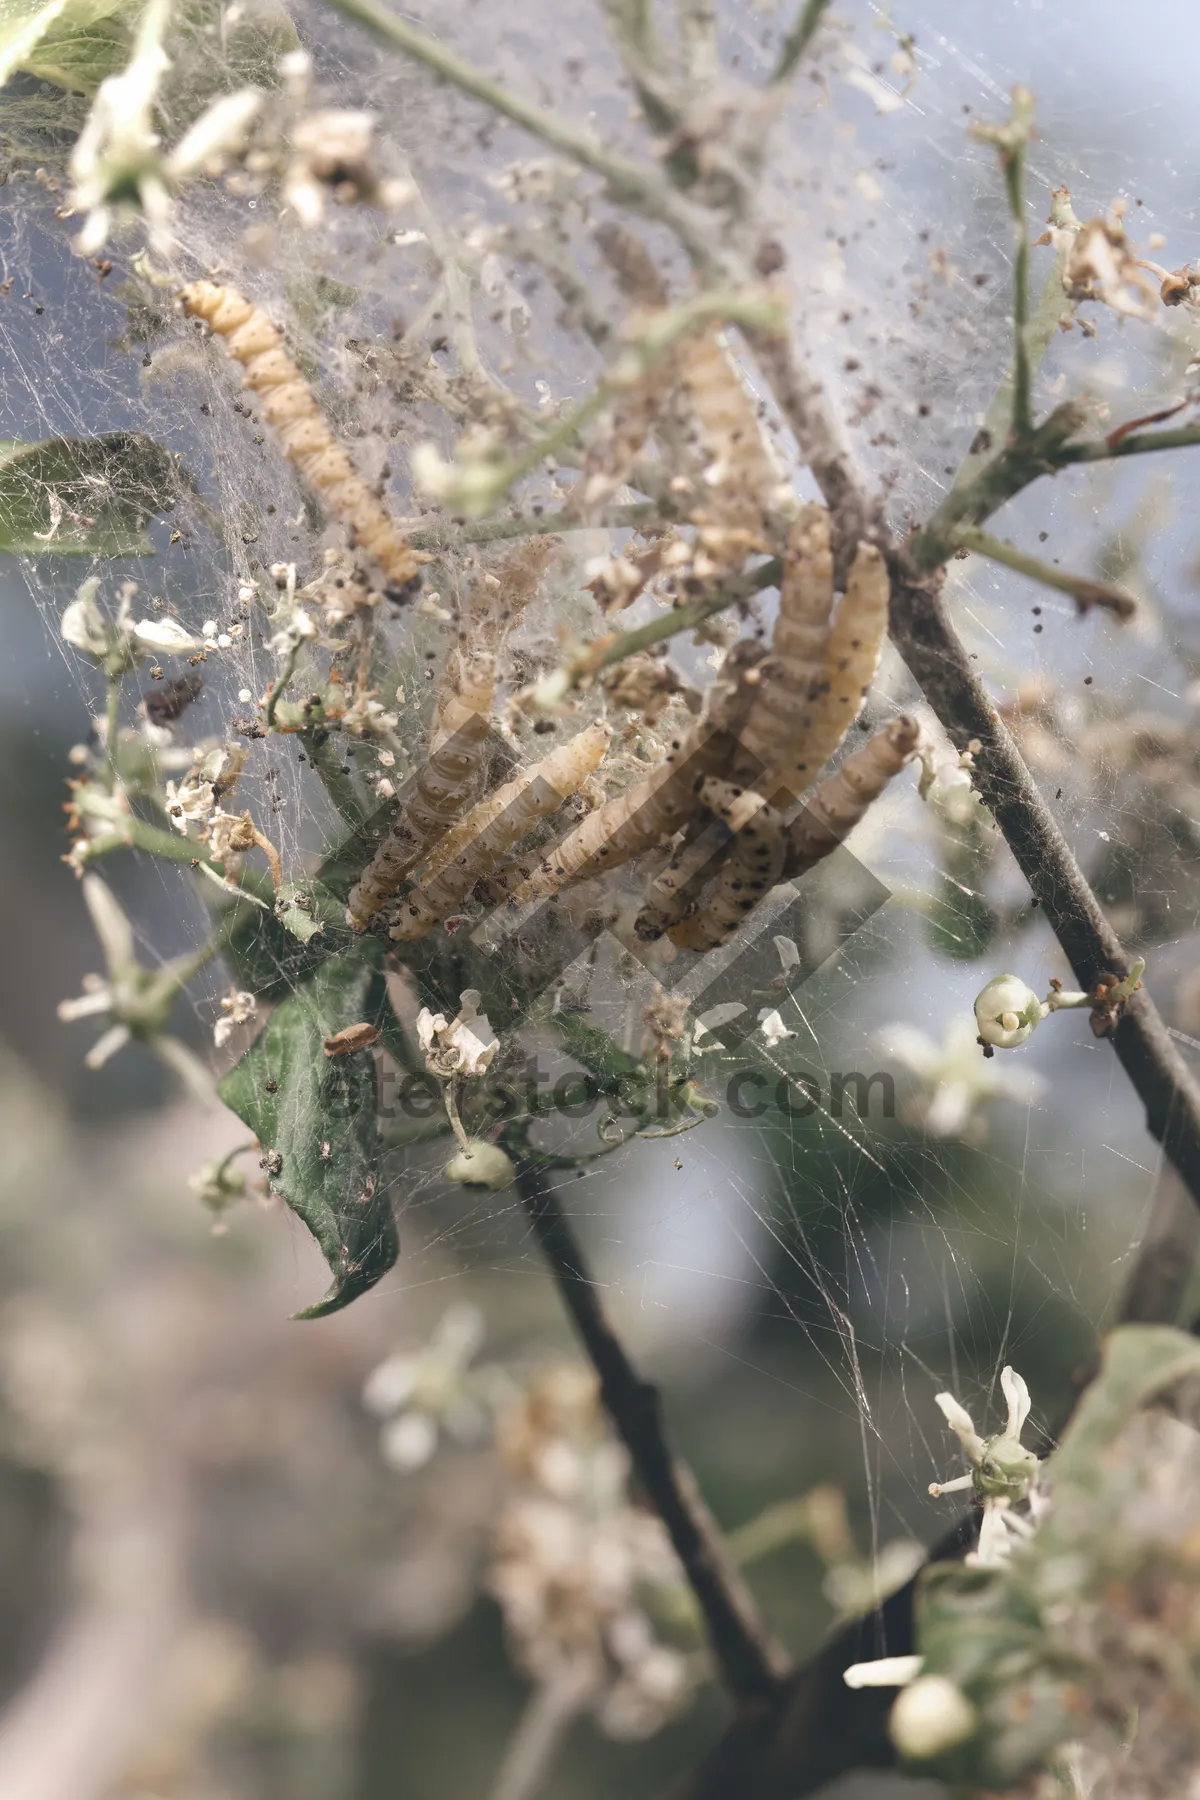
[484,641,763,905]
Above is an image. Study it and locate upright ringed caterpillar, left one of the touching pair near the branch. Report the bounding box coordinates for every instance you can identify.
[734,506,833,787]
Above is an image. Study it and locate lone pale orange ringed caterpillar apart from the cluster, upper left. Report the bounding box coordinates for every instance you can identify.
[180,281,428,594]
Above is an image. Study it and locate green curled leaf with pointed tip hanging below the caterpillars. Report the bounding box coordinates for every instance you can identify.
[219,943,399,1319]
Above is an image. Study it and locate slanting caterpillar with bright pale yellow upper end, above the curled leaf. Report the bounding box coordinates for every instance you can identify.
[390,725,612,941]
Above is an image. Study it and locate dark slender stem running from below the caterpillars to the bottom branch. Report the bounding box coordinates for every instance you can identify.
[507,1130,788,1721]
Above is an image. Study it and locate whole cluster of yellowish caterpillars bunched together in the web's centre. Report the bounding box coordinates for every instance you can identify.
[349,506,919,950]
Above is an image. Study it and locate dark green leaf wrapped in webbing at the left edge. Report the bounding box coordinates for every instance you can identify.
[0,432,178,556]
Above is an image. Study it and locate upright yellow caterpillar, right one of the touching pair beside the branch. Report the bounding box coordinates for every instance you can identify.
[774,544,891,805]
